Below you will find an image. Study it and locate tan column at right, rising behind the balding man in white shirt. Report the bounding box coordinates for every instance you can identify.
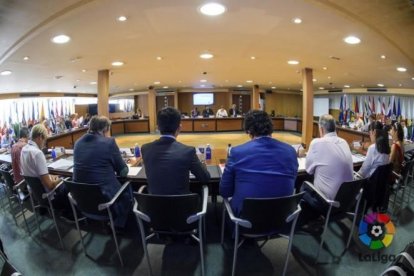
[302,68,313,148]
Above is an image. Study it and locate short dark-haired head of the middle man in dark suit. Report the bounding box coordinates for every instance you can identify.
[157,107,181,136]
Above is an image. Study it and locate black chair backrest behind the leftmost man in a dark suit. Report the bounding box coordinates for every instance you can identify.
[65,180,110,216]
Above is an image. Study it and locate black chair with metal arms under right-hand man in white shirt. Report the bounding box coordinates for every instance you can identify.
[303,175,366,262]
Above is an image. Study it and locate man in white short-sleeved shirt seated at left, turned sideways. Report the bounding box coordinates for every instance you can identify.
[20,124,73,219]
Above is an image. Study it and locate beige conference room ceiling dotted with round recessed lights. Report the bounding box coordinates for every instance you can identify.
[0,0,414,95]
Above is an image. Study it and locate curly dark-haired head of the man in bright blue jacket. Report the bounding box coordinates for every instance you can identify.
[244,110,273,138]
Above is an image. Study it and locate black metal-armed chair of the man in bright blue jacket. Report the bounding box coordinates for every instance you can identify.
[221,193,303,275]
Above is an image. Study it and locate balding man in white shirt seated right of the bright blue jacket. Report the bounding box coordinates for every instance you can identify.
[301,114,353,224]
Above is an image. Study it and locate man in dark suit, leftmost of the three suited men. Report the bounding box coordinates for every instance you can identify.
[73,115,132,230]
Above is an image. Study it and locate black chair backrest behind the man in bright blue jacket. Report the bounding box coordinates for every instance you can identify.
[240,193,303,234]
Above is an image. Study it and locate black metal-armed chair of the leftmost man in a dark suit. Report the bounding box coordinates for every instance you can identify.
[64,179,130,266]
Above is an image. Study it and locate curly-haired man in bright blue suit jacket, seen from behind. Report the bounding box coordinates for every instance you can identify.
[220,110,298,214]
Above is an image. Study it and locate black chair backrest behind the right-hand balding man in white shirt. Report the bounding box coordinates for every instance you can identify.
[335,178,366,212]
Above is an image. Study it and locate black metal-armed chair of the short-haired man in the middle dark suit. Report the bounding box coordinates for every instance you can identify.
[134,186,208,275]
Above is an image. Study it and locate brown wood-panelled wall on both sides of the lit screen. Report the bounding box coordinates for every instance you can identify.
[178,92,231,114]
